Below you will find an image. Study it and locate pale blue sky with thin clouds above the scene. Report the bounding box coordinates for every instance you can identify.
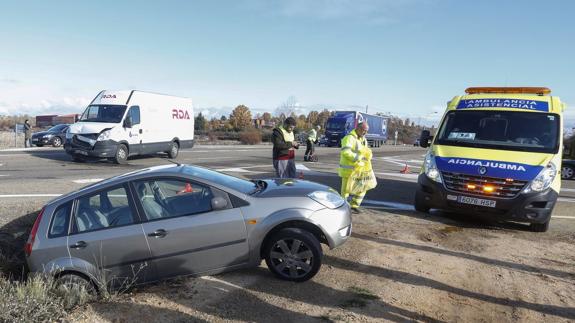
[0,0,575,126]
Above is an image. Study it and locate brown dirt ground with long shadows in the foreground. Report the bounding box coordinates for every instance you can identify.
[70,210,575,322]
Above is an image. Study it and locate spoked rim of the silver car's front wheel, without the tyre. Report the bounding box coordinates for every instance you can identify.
[270,239,314,278]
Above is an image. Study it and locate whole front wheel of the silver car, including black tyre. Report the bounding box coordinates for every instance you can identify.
[264,228,323,282]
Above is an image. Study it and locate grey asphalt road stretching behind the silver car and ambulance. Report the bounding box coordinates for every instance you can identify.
[0,145,575,233]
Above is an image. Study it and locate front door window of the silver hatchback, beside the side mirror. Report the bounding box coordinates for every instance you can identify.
[135,179,227,220]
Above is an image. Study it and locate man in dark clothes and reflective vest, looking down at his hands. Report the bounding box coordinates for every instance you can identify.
[272,117,299,178]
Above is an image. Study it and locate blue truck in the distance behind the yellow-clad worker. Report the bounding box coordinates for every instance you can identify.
[325,111,388,147]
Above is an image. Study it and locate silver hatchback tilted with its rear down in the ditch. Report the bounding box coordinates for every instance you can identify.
[25,165,352,288]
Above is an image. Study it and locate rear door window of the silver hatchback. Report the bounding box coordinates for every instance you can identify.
[74,186,134,233]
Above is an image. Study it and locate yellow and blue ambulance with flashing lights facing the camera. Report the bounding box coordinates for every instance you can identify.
[414,87,565,232]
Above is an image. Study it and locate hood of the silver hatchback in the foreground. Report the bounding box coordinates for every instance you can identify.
[254,178,333,197]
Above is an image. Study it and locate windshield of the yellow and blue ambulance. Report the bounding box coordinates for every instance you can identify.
[436,111,559,153]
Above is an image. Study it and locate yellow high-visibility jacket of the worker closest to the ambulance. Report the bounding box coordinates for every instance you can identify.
[337,129,371,177]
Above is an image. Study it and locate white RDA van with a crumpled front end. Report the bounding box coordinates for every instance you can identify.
[64,90,194,164]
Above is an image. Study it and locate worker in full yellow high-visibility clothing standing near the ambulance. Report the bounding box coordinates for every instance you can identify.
[337,122,372,214]
